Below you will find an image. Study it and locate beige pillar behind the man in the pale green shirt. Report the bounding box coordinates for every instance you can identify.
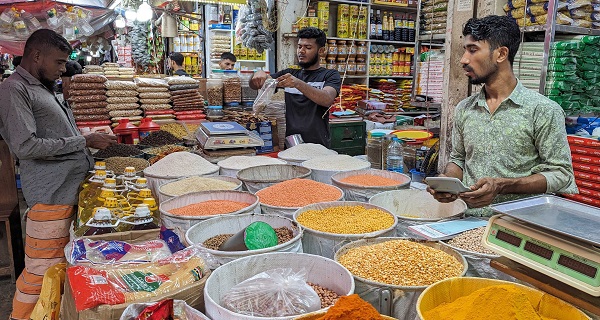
[438,0,475,172]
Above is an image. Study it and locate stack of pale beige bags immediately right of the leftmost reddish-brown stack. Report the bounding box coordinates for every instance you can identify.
[105,80,142,126]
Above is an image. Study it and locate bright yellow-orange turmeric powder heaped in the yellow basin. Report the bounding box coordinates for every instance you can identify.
[423,284,552,320]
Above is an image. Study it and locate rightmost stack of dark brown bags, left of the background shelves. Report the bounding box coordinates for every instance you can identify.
[166,77,204,120]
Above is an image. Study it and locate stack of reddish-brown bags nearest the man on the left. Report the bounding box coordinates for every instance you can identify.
[69,74,110,127]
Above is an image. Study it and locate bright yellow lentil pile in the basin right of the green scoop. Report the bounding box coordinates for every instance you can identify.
[296,206,394,234]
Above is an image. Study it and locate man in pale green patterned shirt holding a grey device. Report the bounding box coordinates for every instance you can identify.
[427,16,577,216]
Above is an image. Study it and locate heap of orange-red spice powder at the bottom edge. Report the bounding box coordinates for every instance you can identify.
[317,294,382,320]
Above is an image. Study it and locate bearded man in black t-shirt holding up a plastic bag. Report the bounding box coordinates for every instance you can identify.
[250,27,341,148]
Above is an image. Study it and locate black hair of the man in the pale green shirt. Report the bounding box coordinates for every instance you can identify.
[463,15,521,66]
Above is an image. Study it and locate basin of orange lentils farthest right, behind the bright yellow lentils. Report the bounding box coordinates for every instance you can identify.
[331,169,411,202]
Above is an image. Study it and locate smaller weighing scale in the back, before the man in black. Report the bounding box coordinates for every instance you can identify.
[196,122,265,150]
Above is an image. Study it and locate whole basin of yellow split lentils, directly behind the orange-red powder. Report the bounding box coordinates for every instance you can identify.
[335,237,467,320]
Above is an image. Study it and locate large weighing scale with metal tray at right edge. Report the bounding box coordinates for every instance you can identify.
[482,196,600,297]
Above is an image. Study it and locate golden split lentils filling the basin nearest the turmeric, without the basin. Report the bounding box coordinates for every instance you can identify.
[339,240,463,287]
